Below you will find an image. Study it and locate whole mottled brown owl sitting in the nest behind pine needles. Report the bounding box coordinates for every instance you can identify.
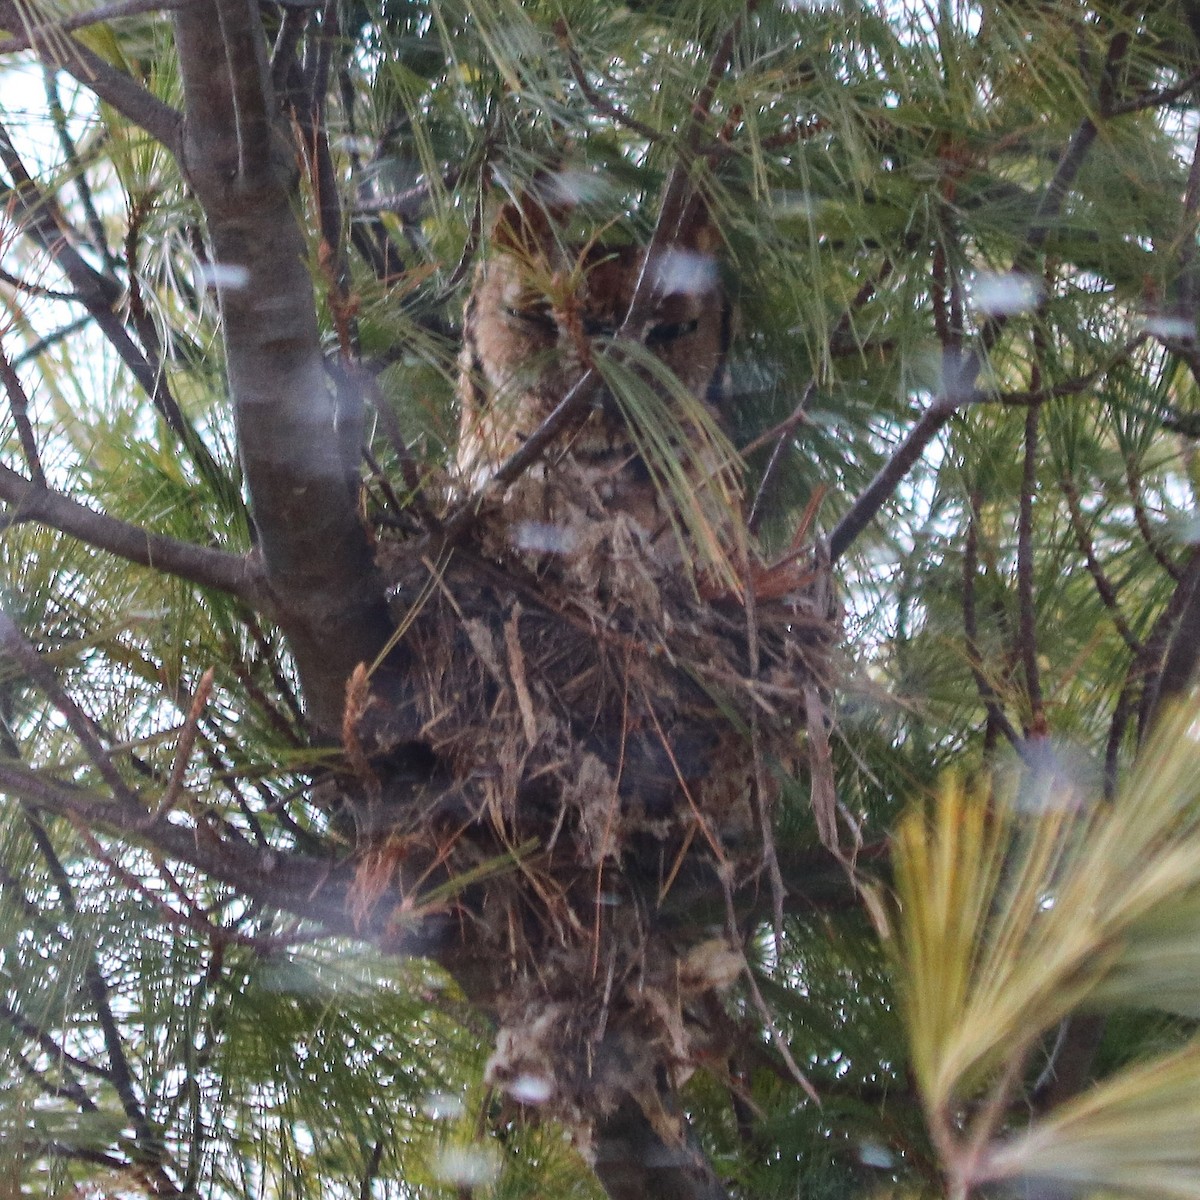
[457,189,736,573]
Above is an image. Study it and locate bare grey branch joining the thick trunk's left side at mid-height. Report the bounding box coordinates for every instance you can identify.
[0,466,271,612]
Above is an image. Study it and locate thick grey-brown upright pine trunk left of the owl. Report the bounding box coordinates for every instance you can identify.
[175,0,390,733]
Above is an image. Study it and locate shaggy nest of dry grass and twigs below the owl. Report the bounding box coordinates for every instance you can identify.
[349,484,836,1135]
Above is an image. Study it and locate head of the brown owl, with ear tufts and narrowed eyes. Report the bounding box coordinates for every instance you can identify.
[460,182,730,472]
